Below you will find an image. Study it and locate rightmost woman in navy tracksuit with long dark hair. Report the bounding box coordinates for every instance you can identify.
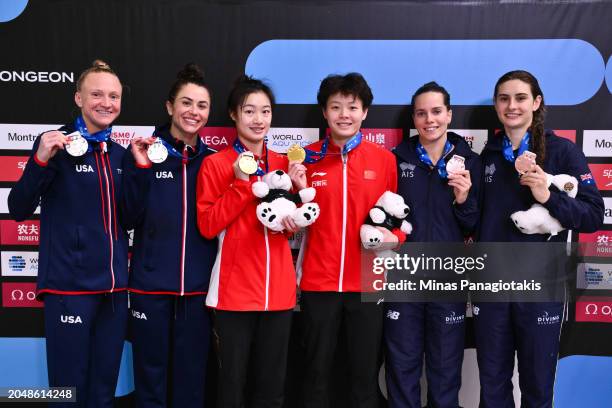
[474,71,604,408]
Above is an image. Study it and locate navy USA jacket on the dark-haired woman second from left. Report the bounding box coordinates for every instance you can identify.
[123,126,217,296]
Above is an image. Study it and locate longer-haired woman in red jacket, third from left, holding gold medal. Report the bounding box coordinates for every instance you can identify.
[197,76,298,408]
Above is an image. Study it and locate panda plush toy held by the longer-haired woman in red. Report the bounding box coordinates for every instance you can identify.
[252,170,320,232]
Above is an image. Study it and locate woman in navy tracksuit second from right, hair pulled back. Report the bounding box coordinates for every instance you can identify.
[384,82,481,408]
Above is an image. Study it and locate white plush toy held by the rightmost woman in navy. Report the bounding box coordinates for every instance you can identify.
[510,174,578,239]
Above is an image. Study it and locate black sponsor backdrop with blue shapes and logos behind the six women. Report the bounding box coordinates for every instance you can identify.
[0,0,612,407]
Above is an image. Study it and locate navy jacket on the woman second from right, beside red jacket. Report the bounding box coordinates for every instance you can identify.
[393,132,482,242]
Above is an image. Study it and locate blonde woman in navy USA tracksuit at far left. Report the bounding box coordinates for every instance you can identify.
[8,61,128,407]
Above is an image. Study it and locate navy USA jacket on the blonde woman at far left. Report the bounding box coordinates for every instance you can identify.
[8,124,128,294]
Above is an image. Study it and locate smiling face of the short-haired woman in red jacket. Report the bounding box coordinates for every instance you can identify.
[323,93,368,144]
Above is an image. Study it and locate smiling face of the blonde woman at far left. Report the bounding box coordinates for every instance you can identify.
[74,72,122,133]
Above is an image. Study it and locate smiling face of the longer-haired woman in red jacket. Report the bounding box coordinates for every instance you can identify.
[230,91,272,147]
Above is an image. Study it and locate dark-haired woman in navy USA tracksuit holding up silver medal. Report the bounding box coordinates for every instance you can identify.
[123,64,217,407]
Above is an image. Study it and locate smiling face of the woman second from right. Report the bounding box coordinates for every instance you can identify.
[412,92,453,144]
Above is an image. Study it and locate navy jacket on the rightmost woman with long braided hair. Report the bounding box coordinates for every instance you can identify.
[478,131,604,242]
